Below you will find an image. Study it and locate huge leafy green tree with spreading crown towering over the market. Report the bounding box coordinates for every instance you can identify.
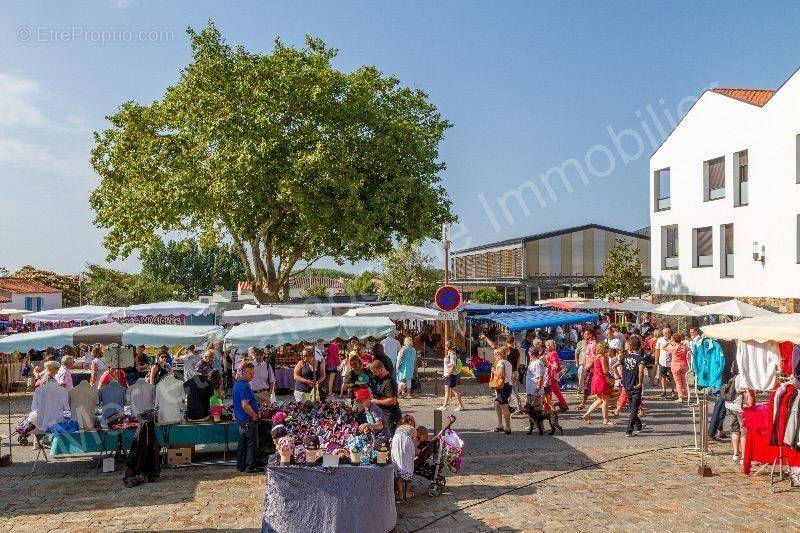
[91,23,453,301]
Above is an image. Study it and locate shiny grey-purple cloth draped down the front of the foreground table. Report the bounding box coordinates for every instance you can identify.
[261,465,397,533]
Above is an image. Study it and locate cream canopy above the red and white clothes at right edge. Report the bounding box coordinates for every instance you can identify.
[700,313,800,344]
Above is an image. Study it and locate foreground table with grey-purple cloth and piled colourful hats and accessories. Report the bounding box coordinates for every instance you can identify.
[262,402,397,532]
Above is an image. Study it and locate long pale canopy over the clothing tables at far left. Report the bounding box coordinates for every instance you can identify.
[0,322,225,353]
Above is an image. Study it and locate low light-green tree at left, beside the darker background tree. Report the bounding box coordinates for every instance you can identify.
[84,265,181,307]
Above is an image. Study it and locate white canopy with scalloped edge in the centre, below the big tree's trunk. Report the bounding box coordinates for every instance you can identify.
[225,316,395,349]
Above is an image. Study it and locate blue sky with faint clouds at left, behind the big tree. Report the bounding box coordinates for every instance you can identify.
[0,0,800,272]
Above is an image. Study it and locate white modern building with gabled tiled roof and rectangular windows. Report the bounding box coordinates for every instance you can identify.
[650,71,800,312]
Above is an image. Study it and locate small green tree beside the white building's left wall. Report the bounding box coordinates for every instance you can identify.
[594,239,646,299]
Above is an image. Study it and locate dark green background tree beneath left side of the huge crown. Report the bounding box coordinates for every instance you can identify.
[139,239,246,300]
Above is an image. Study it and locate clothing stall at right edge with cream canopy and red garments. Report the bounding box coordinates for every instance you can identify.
[701,313,800,491]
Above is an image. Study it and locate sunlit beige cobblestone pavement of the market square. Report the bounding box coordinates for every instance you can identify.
[0,388,800,533]
